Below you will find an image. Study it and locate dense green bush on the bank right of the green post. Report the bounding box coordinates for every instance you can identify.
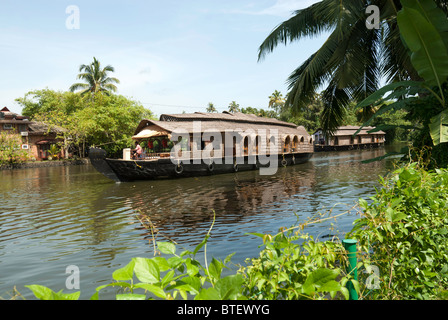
[350,162,448,299]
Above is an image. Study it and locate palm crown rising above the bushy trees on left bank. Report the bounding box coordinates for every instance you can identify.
[70,57,120,95]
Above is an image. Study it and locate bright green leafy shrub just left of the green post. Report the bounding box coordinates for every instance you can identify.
[239,229,358,300]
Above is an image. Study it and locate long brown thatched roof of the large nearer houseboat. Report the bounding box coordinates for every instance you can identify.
[133,112,309,139]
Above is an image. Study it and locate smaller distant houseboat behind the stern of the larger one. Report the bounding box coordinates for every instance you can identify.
[313,126,386,152]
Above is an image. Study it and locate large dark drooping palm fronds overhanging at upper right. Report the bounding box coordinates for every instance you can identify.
[258,0,448,134]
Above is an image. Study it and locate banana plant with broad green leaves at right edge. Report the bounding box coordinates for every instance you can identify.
[355,0,448,145]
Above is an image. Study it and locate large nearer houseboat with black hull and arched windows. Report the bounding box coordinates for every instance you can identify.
[89,112,313,182]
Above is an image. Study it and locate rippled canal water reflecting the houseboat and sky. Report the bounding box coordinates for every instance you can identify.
[0,147,400,299]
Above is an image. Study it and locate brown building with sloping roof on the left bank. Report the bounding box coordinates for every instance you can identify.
[0,107,65,160]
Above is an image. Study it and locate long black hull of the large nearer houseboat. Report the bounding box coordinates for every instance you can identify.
[89,149,313,182]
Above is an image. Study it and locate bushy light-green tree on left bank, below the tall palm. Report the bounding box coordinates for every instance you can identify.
[16,89,153,155]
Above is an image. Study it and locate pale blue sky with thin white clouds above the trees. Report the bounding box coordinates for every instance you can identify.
[0,0,325,116]
